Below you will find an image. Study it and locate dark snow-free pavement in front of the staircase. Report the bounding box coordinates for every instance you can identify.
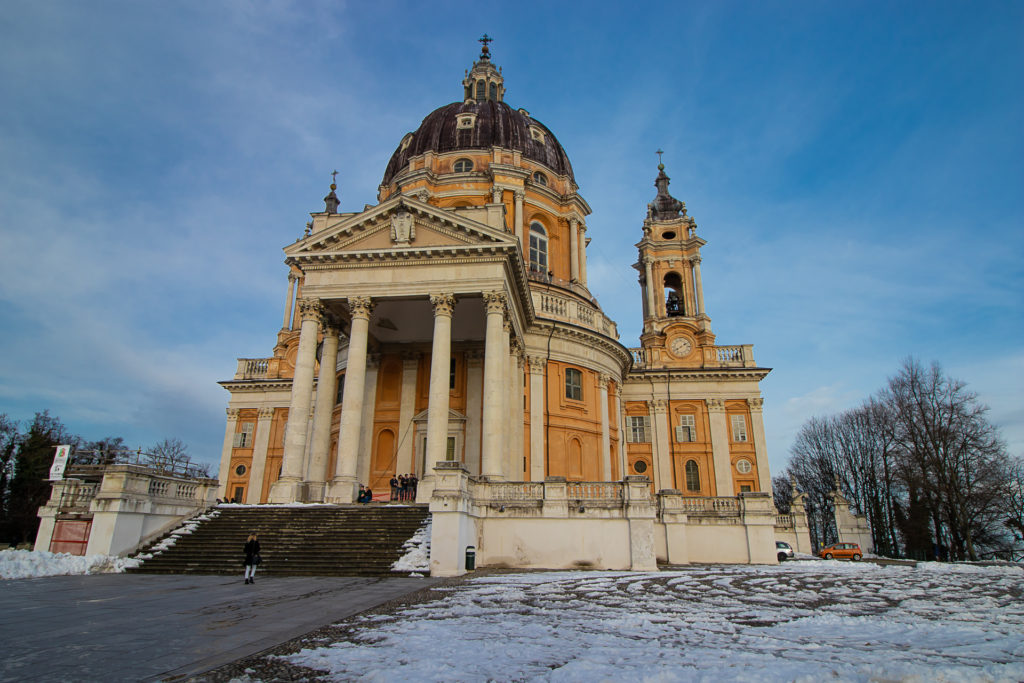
[0,574,439,681]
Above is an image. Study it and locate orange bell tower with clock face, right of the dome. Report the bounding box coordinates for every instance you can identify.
[633,158,715,367]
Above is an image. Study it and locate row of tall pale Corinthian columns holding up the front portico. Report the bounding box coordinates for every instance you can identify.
[268,292,522,503]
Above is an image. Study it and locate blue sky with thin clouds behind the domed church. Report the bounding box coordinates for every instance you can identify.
[0,0,1024,471]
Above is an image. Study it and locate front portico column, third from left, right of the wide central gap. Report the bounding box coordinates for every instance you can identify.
[417,294,456,495]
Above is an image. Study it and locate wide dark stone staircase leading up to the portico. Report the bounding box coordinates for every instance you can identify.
[129,504,430,577]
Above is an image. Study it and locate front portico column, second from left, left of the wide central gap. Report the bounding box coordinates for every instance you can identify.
[326,297,374,503]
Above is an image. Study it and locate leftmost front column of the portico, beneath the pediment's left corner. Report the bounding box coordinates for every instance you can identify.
[269,298,324,503]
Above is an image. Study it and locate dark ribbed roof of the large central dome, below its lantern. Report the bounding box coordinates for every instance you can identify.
[382,99,575,185]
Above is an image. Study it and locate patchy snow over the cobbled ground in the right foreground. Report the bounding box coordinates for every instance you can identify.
[282,561,1024,683]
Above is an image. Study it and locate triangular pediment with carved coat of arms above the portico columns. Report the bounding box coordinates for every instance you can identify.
[285,197,517,262]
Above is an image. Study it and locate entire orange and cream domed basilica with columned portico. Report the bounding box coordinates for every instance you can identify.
[219,40,778,574]
